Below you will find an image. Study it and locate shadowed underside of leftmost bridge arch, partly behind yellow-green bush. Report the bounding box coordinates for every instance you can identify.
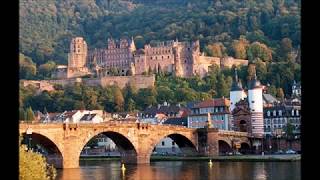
[21,132,63,168]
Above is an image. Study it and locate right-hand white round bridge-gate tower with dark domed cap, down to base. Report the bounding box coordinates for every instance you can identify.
[248,68,264,137]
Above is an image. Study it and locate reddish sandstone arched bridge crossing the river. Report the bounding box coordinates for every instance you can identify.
[19,122,251,168]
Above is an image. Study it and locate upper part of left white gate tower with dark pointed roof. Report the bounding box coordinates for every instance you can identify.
[230,68,246,112]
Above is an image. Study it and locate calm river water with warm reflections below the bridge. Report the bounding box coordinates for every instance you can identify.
[57,160,301,180]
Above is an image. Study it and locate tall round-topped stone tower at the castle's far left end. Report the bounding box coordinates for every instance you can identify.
[68,37,88,68]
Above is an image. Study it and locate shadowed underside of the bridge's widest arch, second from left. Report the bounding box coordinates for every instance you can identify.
[78,131,137,163]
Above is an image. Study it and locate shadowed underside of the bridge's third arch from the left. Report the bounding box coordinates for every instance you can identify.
[147,133,197,156]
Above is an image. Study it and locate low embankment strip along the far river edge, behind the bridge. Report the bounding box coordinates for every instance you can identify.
[80,154,301,162]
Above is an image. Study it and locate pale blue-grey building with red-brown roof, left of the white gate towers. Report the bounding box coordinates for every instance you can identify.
[188,97,231,130]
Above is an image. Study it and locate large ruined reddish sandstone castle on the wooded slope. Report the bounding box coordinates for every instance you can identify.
[55,37,248,79]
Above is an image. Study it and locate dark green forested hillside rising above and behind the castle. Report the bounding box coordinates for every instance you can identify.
[20,0,300,65]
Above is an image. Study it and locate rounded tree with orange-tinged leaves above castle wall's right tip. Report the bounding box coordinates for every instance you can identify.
[247,42,272,62]
